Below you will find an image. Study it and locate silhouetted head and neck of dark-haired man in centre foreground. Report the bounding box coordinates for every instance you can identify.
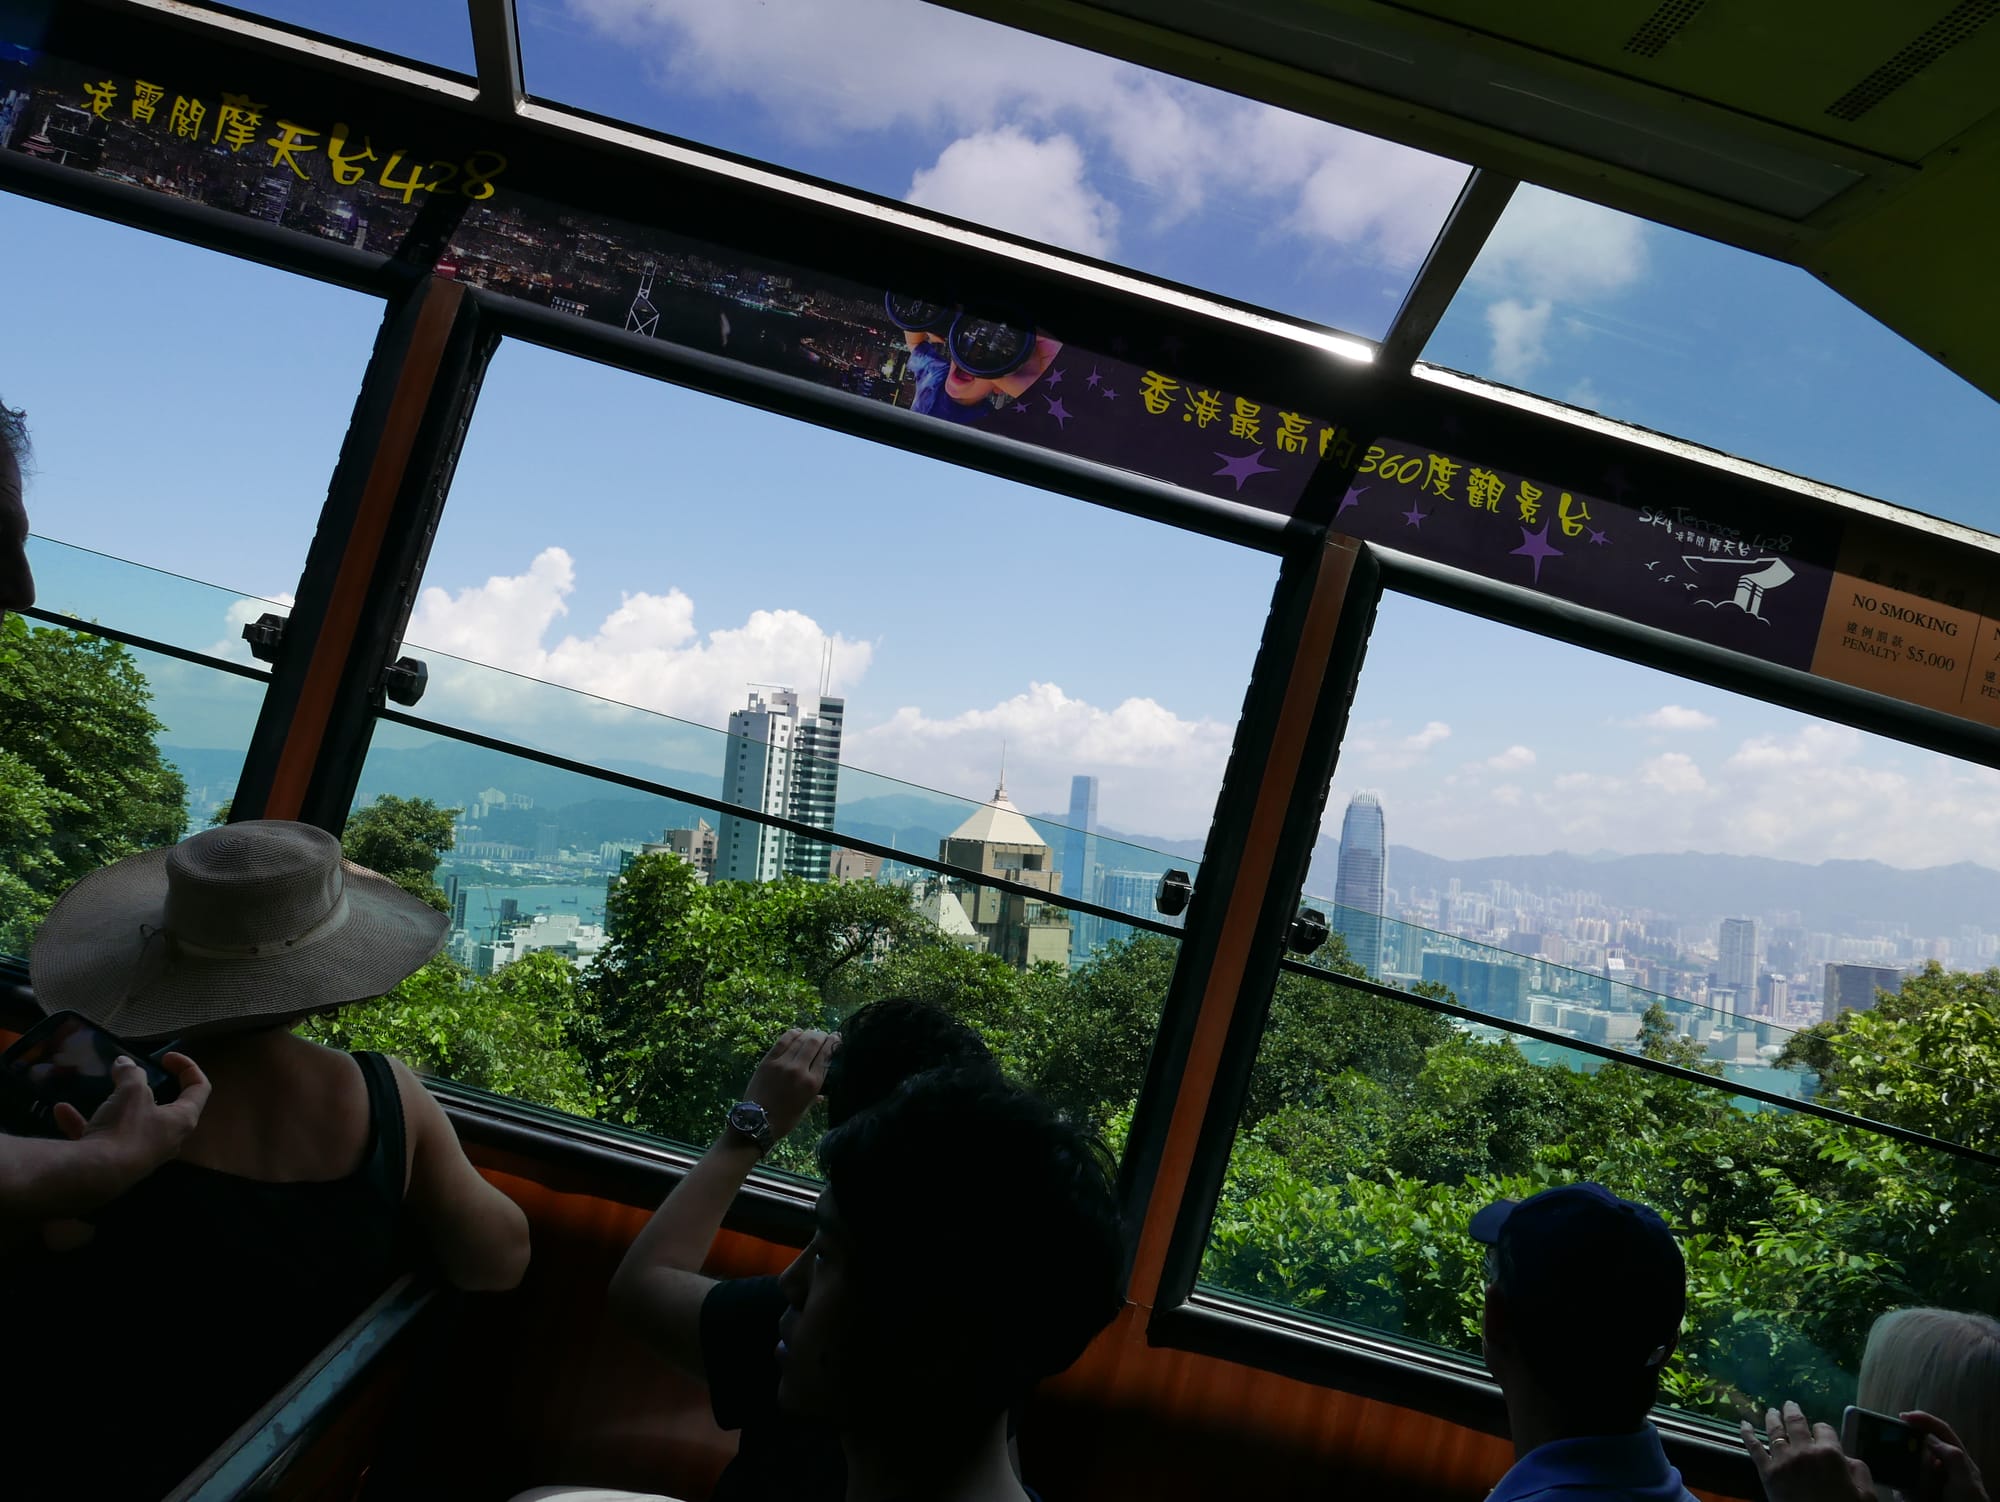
[778,1070,1124,1502]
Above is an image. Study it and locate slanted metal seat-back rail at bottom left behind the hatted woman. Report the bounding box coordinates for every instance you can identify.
[166,1272,438,1502]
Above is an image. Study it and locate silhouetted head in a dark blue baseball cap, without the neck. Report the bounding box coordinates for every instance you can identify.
[1470,1184,1688,1434]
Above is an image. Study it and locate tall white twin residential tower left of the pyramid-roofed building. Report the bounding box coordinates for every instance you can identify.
[716,688,846,882]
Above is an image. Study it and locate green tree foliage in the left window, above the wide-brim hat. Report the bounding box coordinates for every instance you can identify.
[0,616,188,954]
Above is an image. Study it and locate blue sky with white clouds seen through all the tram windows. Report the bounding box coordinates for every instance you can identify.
[0,0,2000,864]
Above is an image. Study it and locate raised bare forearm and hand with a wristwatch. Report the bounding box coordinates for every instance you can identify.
[610,1028,840,1380]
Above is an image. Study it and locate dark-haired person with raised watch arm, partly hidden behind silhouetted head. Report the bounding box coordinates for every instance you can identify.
[610,1000,998,1502]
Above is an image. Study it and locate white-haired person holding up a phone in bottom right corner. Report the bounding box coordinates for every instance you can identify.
[1742,1308,2000,1502]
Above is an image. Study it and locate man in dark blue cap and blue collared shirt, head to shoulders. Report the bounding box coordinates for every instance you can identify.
[1470,1184,1692,1502]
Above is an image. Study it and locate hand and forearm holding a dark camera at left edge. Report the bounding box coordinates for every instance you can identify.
[0,1054,210,1226]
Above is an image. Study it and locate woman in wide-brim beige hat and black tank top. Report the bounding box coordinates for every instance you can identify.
[8,820,528,1496]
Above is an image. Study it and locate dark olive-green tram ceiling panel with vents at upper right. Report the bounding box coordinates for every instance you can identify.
[936,0,2000,398]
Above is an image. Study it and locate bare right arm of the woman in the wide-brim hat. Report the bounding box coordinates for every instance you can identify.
[390,1058,528,1292]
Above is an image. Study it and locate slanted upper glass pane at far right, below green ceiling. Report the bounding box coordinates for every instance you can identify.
[1424,186,2000,532]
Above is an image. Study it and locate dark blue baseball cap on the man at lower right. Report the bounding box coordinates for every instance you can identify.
[1468,1184,1688,1370]
